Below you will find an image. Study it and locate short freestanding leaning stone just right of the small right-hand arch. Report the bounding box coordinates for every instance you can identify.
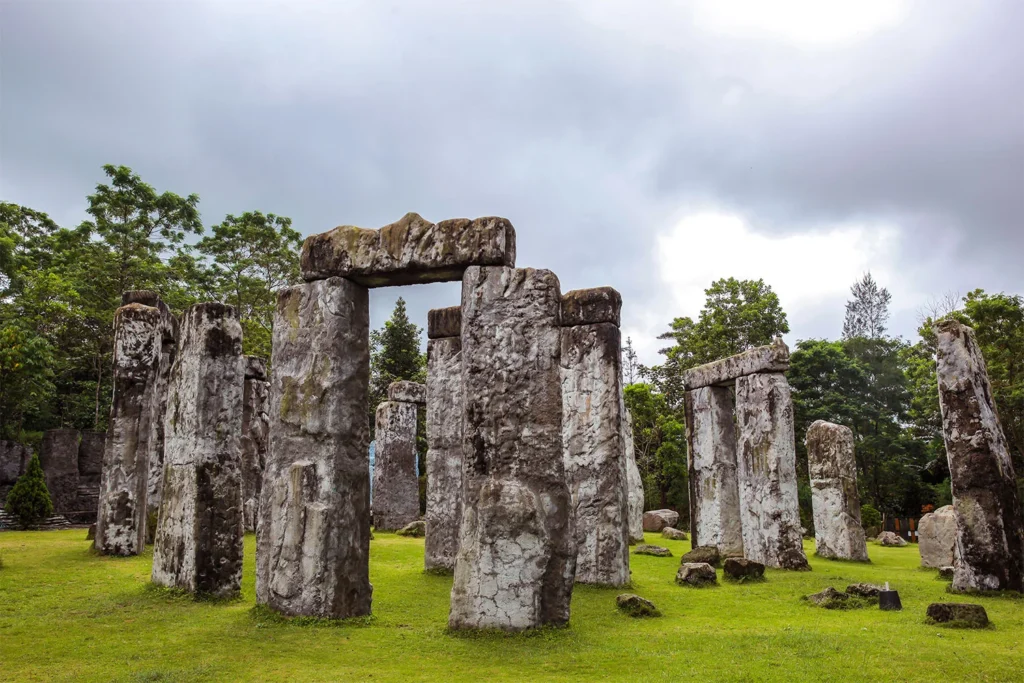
[805,420,868,562]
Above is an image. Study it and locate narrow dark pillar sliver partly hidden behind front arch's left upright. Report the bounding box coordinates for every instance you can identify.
[242,355,270,531]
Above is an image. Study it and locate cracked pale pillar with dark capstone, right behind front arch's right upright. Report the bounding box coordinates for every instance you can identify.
[560,287,630,586]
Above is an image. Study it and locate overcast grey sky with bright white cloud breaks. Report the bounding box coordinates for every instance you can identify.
[0,0,1024,362]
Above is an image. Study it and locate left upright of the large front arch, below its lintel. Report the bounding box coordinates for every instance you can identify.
[256,278,373,617]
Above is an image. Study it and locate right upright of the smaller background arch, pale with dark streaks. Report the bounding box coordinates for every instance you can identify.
[736,373,808,569]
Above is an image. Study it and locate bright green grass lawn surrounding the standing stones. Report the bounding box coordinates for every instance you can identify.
[0,529,1024,683]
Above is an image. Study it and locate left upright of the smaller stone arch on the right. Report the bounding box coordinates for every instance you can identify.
[684,387,743,555]
